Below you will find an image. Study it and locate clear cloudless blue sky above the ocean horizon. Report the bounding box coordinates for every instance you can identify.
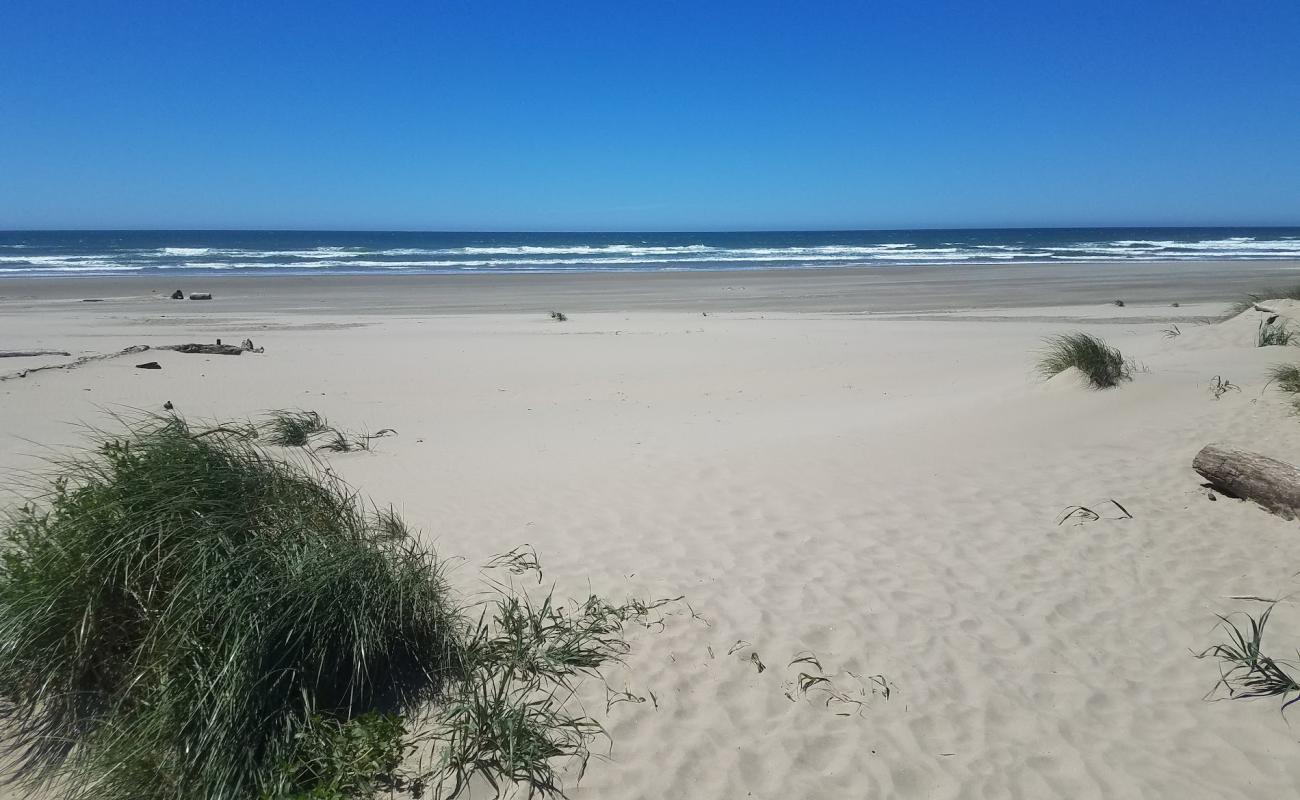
[0,0,1300,230]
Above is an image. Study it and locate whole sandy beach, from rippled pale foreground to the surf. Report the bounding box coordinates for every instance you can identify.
[0,261,1300,800]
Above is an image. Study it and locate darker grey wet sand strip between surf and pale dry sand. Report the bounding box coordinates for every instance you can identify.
[0,260,1300,315]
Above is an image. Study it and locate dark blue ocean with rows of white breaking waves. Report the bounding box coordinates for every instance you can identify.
[0,228,1300,278]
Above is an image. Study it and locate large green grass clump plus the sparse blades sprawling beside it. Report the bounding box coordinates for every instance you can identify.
[0,416,657,800]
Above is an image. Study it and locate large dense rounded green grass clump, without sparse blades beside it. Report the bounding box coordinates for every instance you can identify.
[0,416,465,800]
